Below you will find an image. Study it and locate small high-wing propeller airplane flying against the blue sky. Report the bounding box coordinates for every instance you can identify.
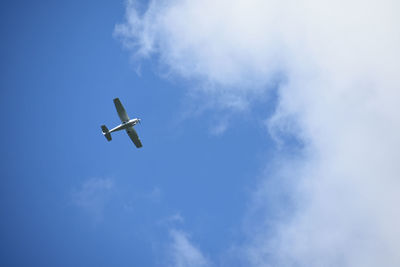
[101,98,142,148]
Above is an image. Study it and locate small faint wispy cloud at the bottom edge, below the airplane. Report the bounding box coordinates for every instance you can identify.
[168,229,211,267]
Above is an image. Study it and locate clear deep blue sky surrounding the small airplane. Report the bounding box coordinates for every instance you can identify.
[0,1,282,266]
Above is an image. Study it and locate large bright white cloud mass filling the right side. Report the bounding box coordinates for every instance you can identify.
[116,0,400,267]
